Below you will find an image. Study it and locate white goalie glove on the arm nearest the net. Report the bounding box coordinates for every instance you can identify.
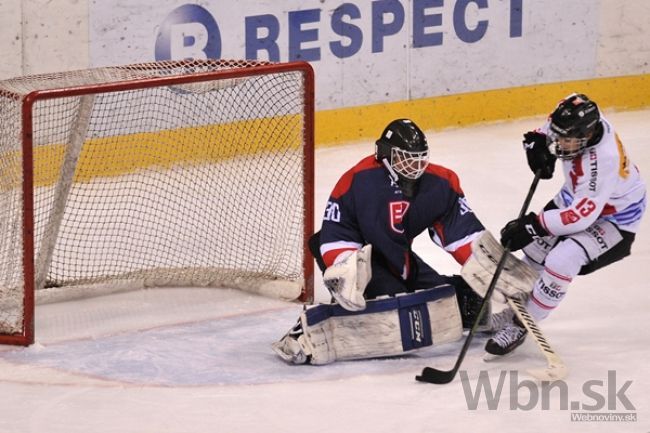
[323,244,372,311]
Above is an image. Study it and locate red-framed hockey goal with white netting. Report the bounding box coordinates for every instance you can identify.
[0,60,314,344]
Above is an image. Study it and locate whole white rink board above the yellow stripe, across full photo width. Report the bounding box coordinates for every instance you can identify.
[0,0,650,118]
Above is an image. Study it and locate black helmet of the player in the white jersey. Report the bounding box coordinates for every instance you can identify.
[549,93,602,159]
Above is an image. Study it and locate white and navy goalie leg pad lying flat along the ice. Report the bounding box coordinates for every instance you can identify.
[288,285,462,364]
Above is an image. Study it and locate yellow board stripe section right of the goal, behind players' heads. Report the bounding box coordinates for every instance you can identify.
[316,74,650,146]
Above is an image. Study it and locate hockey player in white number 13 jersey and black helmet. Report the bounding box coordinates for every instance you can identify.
[485,93,646,355]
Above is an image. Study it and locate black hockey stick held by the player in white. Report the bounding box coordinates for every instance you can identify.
[415,170,541,384]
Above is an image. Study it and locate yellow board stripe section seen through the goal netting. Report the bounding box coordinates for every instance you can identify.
[23,115,303,186]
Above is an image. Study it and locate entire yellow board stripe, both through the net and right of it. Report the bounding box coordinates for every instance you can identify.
[5,74,650,189]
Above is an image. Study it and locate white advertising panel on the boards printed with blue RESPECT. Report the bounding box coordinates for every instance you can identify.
[89,0,601,110]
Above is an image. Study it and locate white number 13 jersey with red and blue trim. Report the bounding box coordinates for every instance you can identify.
[539,114,646,236]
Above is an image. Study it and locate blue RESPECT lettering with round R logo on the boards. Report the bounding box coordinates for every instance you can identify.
[155,0,523,62]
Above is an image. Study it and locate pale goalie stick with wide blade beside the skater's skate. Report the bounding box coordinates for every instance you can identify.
[508,298,568,382]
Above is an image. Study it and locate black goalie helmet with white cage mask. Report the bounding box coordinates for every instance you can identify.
[375,119,429,197]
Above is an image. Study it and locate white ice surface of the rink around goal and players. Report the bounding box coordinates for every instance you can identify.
[0,110,650,433]
